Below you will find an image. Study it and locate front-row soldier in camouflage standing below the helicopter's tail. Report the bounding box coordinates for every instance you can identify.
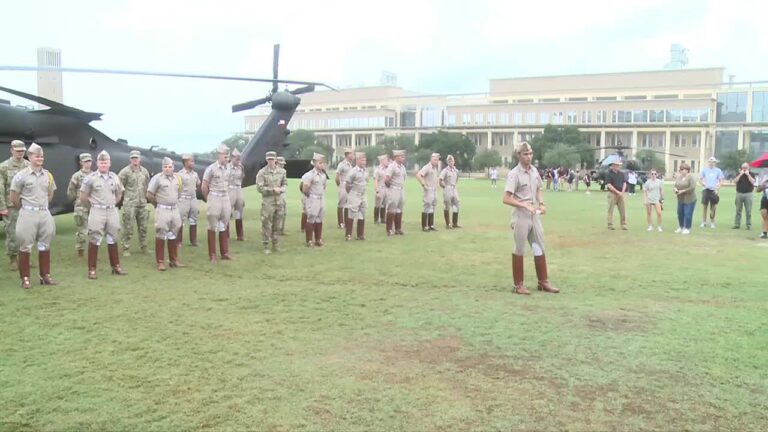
[256,152,288,254]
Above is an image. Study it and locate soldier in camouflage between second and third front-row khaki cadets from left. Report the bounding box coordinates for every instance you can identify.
[117,150,149,256]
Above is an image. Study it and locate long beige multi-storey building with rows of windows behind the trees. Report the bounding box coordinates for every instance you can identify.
[245,68,768,172]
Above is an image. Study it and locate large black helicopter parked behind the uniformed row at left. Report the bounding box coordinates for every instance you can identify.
[0,45,335,214]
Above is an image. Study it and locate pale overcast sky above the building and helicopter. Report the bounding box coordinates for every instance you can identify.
[0,0,768,151]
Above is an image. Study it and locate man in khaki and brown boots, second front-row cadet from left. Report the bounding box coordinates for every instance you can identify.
[80,151,127,279]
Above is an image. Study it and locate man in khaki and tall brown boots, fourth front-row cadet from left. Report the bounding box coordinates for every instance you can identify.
[201,144,232,263]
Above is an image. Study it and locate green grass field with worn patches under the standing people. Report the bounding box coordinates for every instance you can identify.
[0,179,768,431]
